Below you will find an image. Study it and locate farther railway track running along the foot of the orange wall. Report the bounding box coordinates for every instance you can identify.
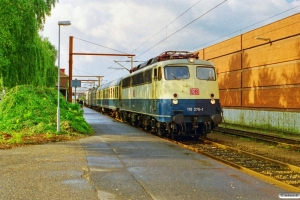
[214,127,300,151]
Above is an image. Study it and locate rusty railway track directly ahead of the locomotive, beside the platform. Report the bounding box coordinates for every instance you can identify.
[173,139,300,192]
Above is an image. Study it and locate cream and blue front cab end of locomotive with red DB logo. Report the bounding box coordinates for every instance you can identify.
[152,52,222,137]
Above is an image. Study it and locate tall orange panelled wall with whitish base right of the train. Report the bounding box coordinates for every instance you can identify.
[198,14,300,134]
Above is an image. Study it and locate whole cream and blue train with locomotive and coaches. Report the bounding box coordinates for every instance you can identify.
[84,51,223,139]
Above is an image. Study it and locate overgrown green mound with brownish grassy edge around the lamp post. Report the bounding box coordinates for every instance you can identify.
[0,85,94,149]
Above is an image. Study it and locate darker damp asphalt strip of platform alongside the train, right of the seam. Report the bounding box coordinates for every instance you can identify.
[80,108,286,200]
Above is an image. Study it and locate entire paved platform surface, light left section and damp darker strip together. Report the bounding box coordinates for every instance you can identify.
[0,108,286,200]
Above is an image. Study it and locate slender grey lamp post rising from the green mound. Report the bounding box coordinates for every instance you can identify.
[57,21,71,133]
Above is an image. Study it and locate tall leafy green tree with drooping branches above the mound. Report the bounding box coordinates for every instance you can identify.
[0,0,57,88]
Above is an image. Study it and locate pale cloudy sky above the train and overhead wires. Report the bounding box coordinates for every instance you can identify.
[40,0,300,90]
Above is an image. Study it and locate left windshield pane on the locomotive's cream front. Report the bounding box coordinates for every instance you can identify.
[165,66,190,80]
